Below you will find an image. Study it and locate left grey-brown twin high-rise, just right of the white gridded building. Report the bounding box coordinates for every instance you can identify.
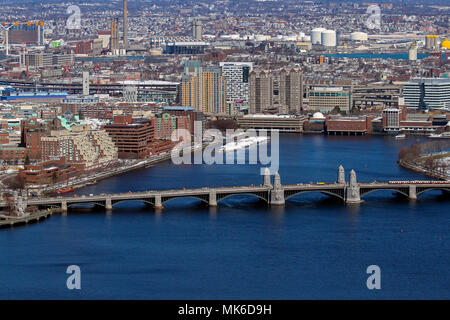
[250,70,273,114]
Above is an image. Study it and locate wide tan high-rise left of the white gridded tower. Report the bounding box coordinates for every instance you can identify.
[181,67,226,114]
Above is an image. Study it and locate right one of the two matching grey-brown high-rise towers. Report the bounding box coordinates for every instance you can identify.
[279,69,303,114]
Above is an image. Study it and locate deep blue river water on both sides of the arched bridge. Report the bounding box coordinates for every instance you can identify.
[0,135,450,299]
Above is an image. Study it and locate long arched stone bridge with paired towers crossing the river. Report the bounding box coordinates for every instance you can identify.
[0,166,450,212]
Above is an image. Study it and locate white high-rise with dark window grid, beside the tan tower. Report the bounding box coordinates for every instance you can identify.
[220,62,253,104]
